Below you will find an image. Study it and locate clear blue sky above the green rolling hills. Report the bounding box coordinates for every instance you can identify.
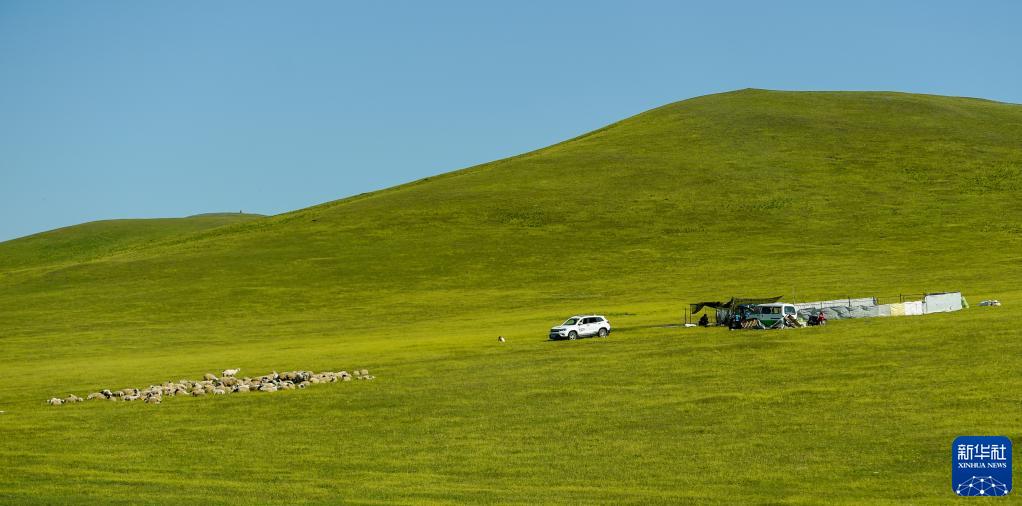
[0,0,1022,240]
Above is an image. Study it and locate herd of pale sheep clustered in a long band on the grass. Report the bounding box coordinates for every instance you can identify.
[46,369,375,406]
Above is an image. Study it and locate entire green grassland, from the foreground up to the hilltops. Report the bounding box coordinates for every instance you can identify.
[0,90,1022,504]
